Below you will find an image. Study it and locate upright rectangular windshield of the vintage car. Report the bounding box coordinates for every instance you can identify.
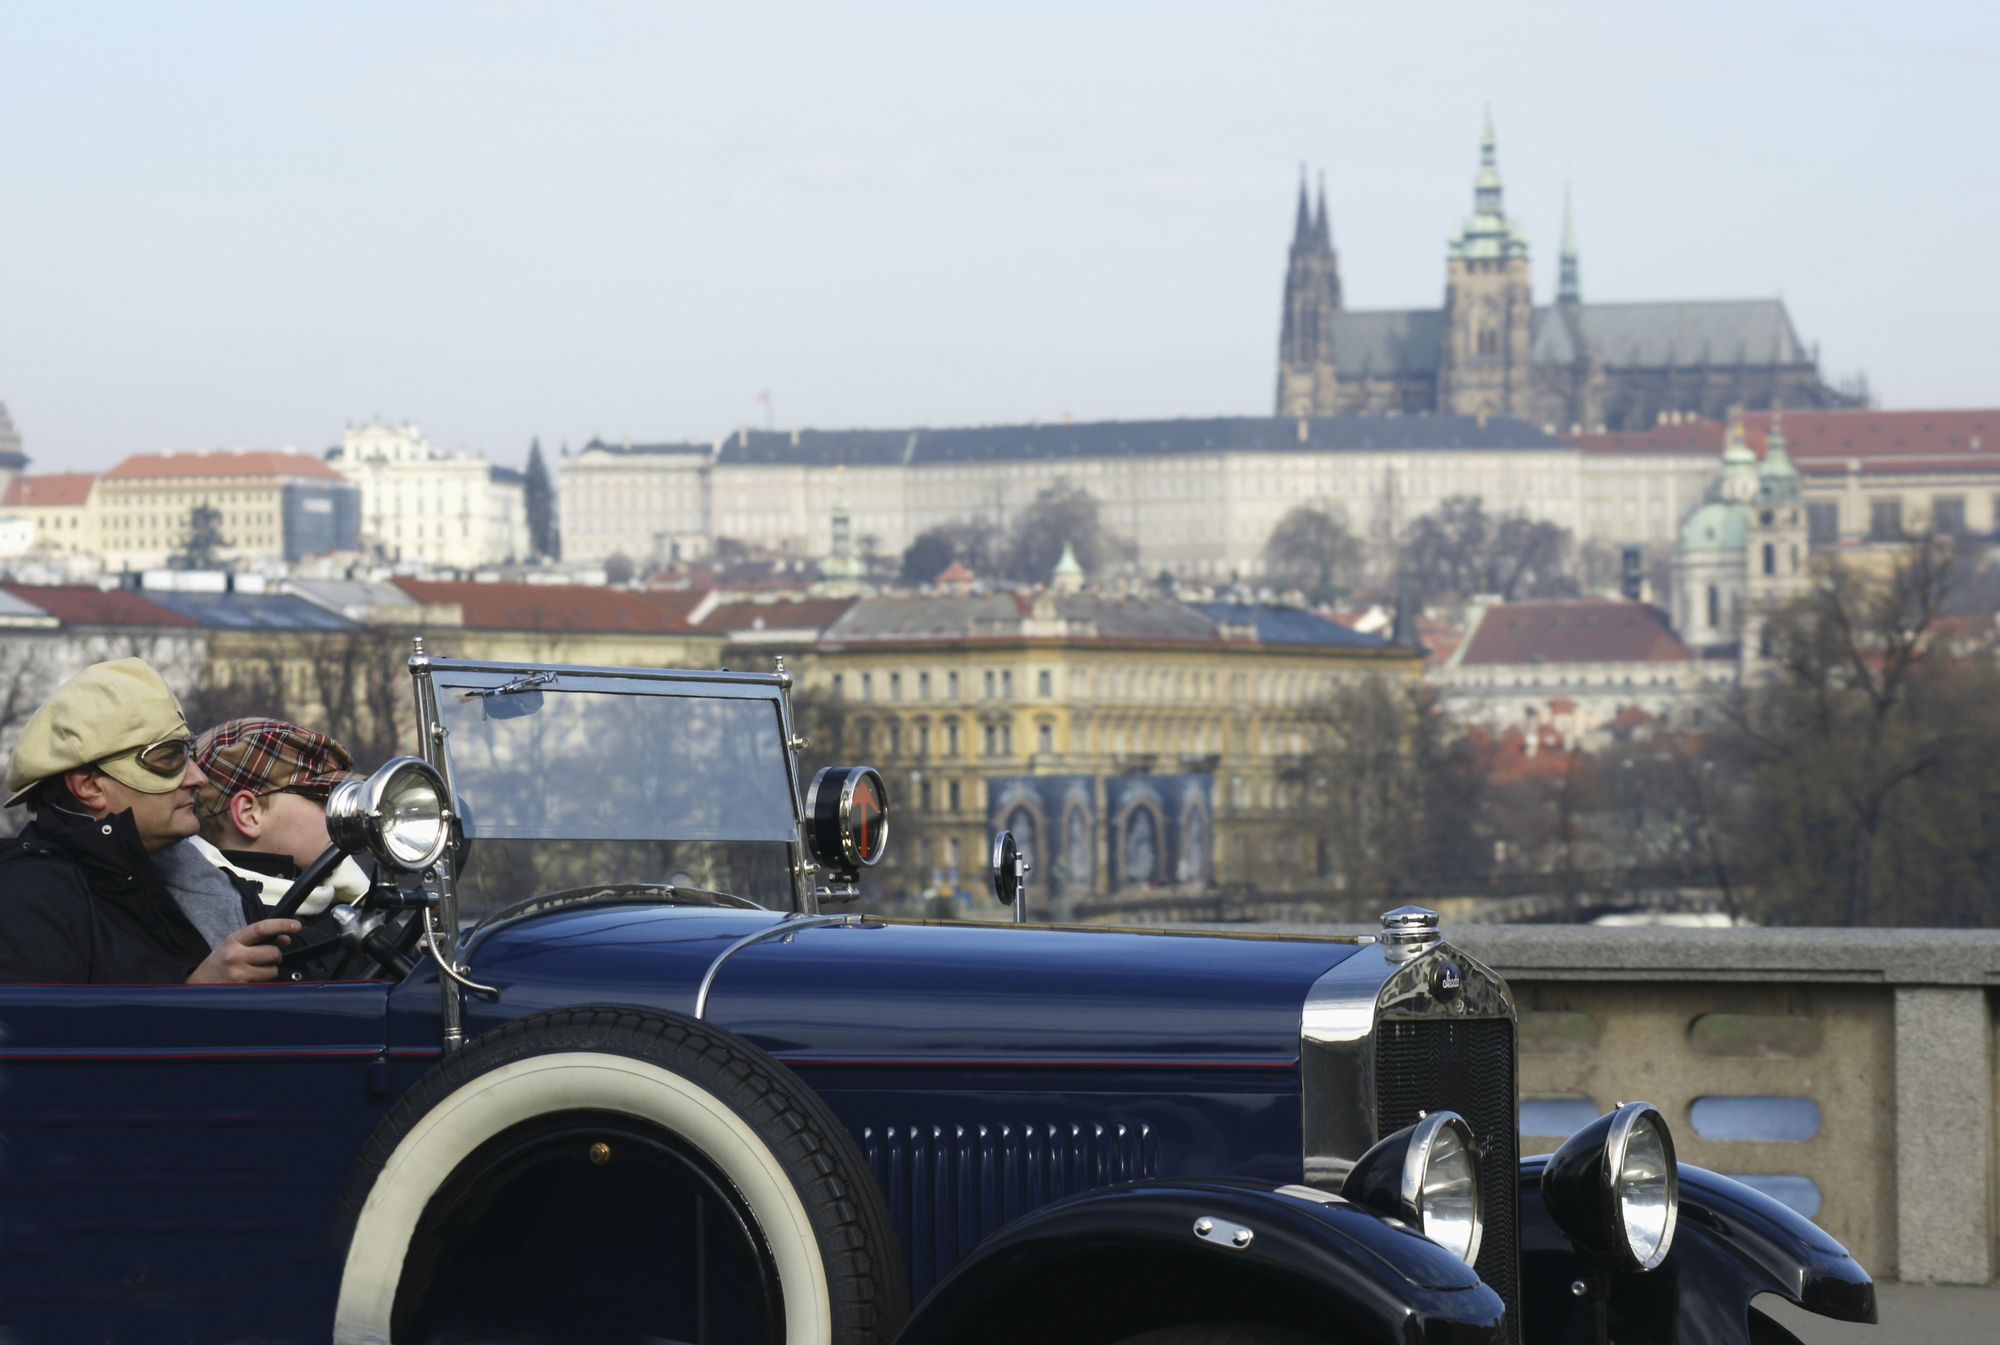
[436,670,798,921]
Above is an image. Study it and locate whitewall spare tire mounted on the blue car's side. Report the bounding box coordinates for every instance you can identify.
[334,1009,908,1345]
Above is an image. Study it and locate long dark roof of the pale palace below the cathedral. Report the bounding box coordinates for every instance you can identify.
[716,416,1560,466]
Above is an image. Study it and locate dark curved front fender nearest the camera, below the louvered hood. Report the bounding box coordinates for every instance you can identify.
[896,1177,1504,1345]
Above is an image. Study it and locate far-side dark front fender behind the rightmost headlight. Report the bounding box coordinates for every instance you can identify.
[1520,1157,1876,1345]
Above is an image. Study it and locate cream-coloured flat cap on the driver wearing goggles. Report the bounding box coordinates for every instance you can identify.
[6,658,188,809]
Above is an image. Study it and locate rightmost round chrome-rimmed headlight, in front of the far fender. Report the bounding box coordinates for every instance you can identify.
[1542,1103,1680,1271]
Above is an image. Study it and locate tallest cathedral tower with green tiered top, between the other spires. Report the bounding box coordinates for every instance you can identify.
[1438,108,1536,416]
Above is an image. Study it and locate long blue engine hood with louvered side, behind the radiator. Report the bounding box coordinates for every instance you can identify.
[454,907,1356,1297]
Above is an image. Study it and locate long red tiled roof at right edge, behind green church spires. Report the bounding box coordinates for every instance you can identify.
[1744,410,2000,476]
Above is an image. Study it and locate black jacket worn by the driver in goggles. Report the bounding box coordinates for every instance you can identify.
[0,809,219,985]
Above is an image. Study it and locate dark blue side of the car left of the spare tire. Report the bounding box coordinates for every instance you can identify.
[0,981,390,1341]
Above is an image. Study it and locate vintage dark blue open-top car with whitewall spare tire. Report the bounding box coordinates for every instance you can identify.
[0,646,1874,1345]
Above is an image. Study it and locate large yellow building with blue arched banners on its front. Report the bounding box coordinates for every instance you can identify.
[804,592,1422,915]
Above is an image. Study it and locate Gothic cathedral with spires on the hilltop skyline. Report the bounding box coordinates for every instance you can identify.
[1276,116,1864,432]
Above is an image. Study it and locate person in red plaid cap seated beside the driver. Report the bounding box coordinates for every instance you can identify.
[194,719,368,924]
